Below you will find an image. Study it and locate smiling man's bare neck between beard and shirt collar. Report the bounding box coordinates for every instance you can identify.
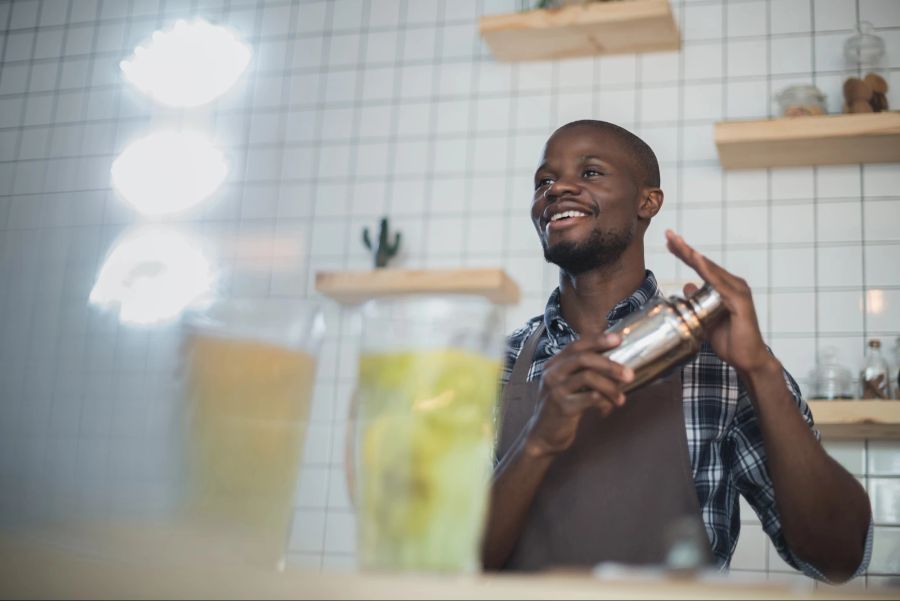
[559,254,646,338]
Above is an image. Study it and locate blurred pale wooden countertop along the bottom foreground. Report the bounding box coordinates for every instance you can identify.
[0,536,900,599]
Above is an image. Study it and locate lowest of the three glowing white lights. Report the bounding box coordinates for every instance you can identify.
[90,226,215,325]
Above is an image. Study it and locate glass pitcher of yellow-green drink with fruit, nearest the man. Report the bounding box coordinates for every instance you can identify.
[347,295,504,572]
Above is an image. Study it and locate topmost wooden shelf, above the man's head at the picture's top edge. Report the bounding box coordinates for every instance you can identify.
[479,0,681,61]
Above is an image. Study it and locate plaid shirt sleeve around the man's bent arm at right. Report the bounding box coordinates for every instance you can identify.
[726,364,873,582]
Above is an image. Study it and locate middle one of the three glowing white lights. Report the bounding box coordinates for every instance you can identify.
[111,131,228,216]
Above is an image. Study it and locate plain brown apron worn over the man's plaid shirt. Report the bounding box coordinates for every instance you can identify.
[497,325,710,570]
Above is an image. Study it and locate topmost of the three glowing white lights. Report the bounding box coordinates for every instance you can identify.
[119,19,250,107]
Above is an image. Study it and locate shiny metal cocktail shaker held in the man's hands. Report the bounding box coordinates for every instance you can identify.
[603,284,725,392]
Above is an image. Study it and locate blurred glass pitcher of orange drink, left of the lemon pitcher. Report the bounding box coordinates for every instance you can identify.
[183,299,325,568]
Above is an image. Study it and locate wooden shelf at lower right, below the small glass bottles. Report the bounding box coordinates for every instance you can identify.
[809,400,900,439]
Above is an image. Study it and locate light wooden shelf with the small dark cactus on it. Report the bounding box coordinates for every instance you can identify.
[316,269,519,305]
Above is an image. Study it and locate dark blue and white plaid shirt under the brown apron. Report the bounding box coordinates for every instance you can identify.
[502,271,872,580]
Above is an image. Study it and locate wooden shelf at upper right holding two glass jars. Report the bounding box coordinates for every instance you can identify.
[715,111,900,169]
